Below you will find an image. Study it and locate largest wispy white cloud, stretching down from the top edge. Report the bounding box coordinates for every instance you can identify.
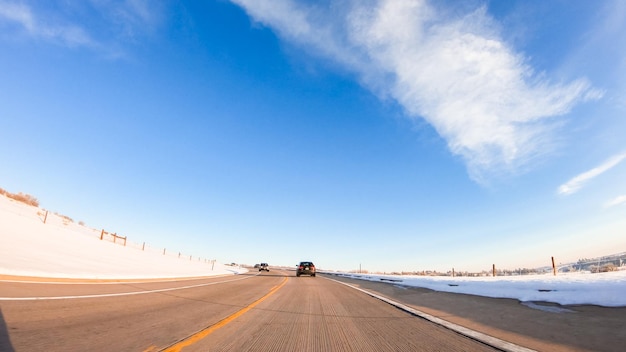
[231,0,602,181]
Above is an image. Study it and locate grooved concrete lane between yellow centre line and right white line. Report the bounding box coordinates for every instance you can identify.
[164,275,496,352]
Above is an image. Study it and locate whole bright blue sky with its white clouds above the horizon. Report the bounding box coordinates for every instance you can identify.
[0,0,626,271]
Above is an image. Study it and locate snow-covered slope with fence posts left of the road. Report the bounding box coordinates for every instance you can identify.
[0,195,247,279]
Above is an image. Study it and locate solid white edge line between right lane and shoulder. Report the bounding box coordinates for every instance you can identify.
[325,278,537,352]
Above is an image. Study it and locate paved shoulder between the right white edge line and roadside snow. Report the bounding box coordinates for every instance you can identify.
[330,276,626,352]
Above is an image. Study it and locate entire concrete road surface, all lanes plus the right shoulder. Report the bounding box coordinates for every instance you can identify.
[0,270,626,352]
